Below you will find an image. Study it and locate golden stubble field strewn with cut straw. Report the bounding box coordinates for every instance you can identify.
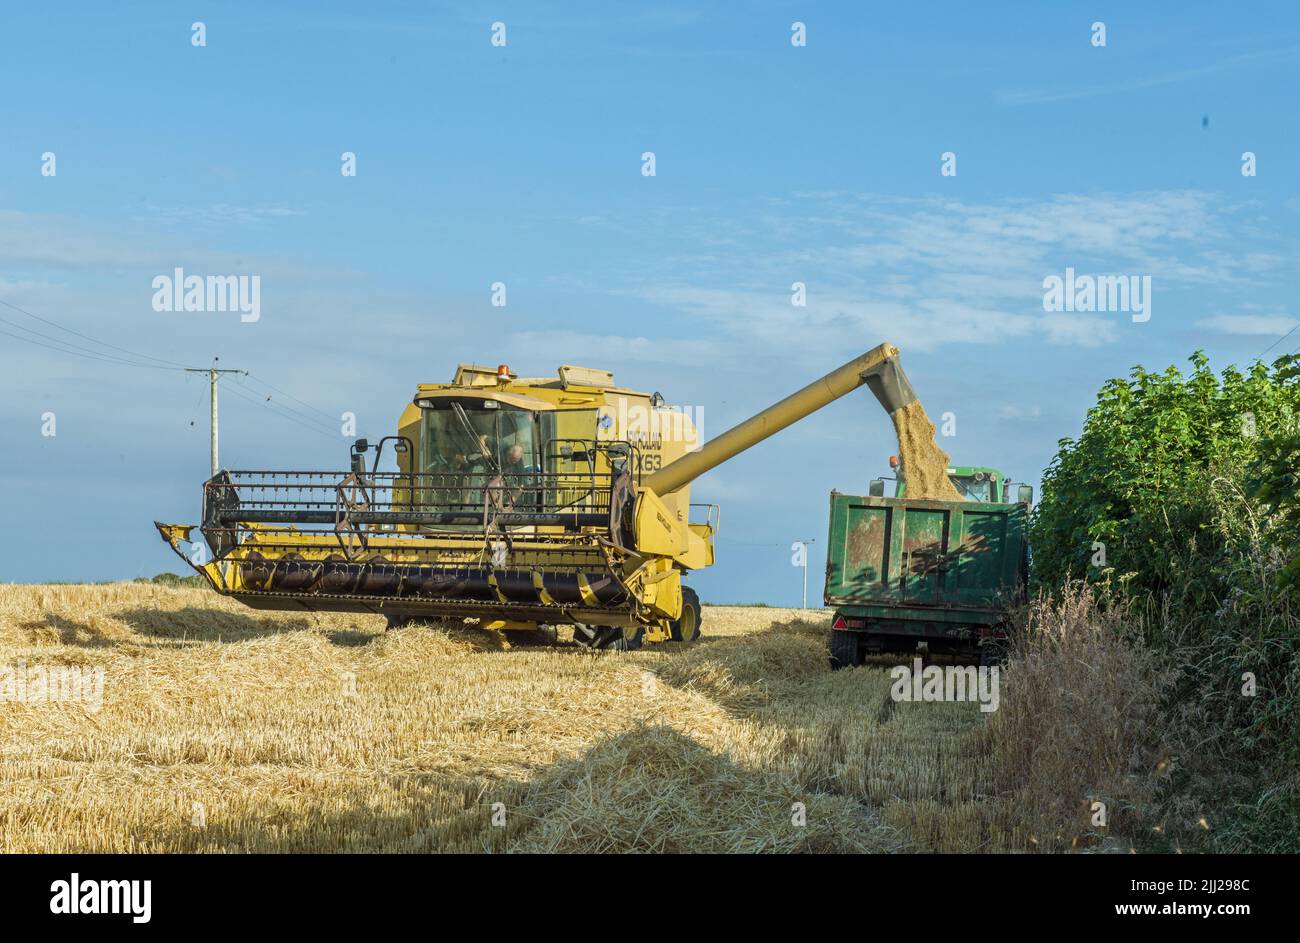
[0,584,1034,852]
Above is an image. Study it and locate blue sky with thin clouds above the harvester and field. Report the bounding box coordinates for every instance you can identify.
[0,0,1300,604]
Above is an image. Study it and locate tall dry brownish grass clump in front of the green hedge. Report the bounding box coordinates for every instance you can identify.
[989,583,1171,851]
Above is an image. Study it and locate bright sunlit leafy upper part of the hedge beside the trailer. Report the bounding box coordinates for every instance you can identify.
[1031,352,1300,605]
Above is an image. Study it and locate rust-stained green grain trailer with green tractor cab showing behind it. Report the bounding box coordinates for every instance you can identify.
[826,468,1032,667]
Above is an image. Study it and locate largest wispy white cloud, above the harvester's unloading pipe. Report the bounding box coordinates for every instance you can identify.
[589,191,1248,356]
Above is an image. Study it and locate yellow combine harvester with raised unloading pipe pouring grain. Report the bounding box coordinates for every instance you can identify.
[156,343,915,649]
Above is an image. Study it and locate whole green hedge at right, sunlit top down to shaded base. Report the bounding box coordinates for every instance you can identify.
[1030,352,1300,851]
